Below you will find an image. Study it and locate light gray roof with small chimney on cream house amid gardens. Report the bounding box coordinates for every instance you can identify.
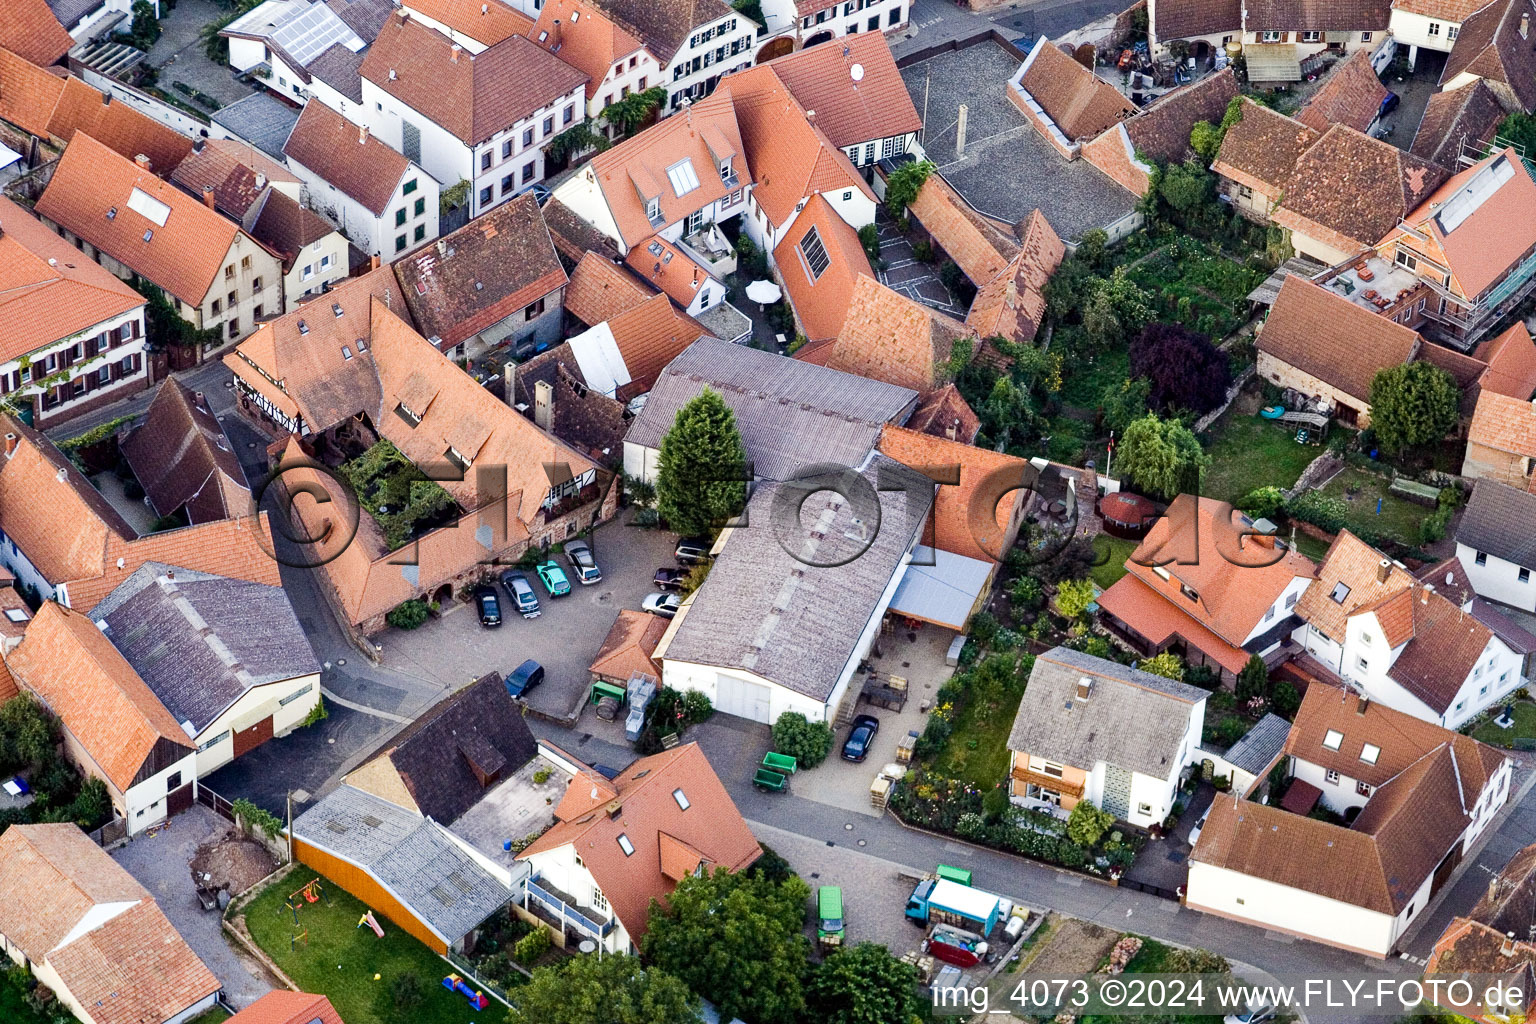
[1008,648,1207,778]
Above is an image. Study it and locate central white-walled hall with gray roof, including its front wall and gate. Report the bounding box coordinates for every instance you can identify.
[656,453,934,722]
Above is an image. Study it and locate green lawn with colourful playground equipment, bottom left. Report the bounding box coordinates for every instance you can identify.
[244,867,491,1024]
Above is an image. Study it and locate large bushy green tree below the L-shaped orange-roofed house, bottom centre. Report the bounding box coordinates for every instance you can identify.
[641,869,811,1024]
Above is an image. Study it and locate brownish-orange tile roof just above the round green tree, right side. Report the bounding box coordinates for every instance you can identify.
[1258,275,1419,402]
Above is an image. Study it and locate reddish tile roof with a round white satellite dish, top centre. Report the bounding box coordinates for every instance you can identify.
[768,32,923,149]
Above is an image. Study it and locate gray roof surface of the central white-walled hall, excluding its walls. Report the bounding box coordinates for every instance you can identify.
[664,457,932,702]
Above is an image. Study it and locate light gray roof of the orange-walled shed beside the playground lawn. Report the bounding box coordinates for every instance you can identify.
[293,786,511,943]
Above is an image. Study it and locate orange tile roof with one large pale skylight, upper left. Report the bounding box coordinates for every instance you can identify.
[37,134,255,306]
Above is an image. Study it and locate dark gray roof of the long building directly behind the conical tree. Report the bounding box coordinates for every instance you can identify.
[625,338,917,481]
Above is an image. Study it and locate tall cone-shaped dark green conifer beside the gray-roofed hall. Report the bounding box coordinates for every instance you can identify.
[656,387,746,536]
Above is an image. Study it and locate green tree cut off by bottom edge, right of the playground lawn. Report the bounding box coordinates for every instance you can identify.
[507,956,700,1024]
